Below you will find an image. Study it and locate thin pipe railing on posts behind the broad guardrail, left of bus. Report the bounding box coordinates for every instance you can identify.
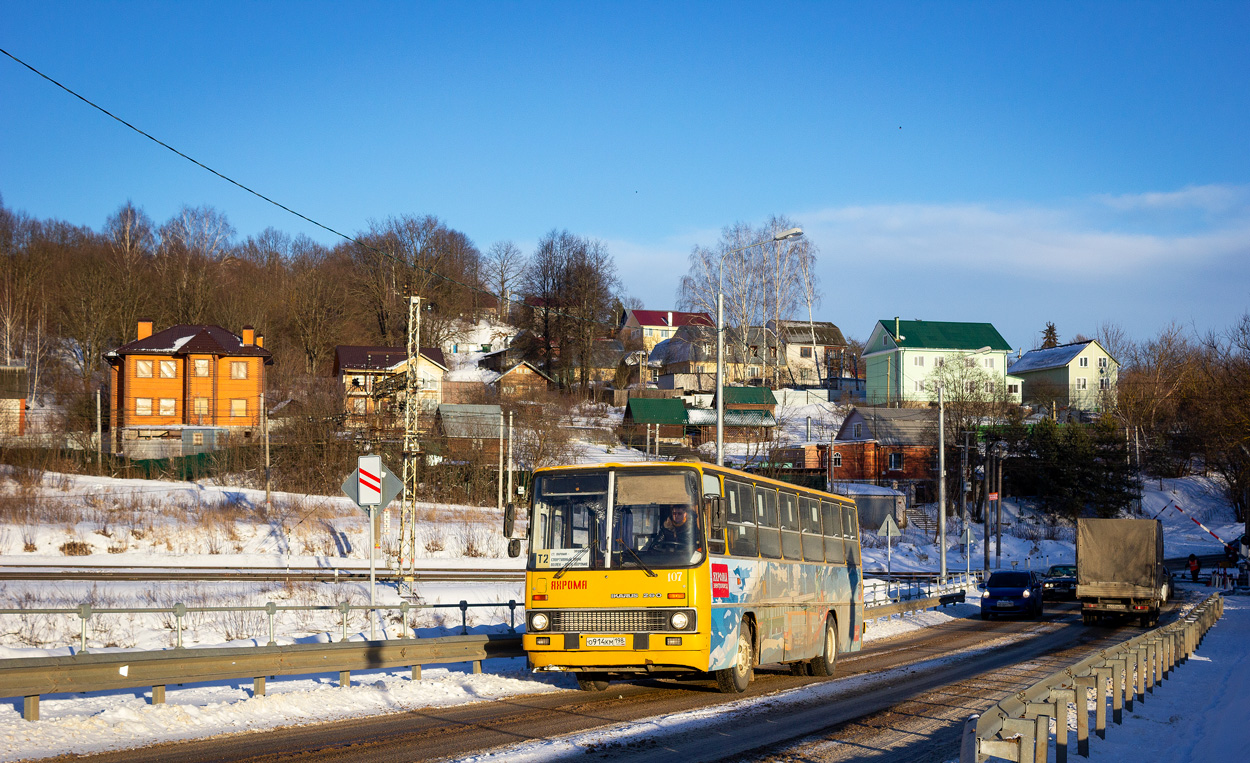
[0,599,525,654]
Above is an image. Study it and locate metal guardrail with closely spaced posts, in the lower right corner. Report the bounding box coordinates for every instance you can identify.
[959,594,1224,763]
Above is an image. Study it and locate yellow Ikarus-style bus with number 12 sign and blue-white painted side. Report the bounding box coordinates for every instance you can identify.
[504,462,864,693]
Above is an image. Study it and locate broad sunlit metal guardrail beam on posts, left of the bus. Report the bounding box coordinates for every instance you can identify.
[0,634,525,720]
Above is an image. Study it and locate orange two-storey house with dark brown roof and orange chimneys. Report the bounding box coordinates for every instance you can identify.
[105,320,274,458]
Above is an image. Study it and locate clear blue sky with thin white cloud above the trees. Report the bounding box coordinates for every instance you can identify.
[0,0,1250,349]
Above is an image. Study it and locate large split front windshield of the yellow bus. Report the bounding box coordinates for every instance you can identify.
[530,469,705,569]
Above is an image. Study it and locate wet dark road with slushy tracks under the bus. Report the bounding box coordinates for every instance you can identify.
[36,603,1160,763]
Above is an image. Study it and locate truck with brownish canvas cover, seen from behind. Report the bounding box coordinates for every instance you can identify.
[1076,519,1170,628]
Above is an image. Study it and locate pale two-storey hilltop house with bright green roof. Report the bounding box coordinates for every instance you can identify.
[864,318,1021,405]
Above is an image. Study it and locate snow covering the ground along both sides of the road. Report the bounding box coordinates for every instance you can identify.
[0,465,1250,760]
